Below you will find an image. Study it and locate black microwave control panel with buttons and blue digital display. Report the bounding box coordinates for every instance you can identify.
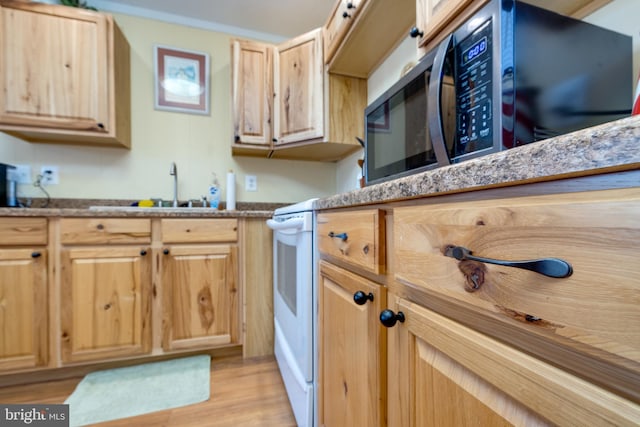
[450,20,494,159]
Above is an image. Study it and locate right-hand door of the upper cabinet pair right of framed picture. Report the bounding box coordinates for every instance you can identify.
[274,28,324,145]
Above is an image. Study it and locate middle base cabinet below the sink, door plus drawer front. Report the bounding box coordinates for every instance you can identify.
[60,218,152,364]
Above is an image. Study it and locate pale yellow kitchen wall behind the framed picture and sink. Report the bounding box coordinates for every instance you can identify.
[0,2,638,426]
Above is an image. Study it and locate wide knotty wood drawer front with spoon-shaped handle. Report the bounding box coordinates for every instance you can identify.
[393,189,640,399]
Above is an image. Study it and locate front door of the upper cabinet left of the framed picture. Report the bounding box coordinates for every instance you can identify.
[0,3,109,131]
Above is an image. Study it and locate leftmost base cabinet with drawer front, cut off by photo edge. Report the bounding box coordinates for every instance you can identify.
[0,218,49,372]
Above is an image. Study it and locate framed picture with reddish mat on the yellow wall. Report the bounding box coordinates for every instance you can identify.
[153,45,209,115]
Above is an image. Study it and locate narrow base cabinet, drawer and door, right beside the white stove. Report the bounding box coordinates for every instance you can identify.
[317,209,386,427]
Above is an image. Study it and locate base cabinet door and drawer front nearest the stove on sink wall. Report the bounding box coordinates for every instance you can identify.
[162,218,240,351]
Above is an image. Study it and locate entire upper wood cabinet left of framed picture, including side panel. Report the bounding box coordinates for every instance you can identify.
[0,0,131,148]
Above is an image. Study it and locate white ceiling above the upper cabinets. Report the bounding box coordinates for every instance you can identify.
[93,0,336,41]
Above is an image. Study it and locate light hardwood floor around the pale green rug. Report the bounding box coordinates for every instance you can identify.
[0,356,296,427]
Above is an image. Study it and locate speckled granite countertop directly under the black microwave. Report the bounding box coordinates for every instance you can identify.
[314,116,640,210]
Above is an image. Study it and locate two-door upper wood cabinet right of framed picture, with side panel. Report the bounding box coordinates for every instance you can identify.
[231,29,367,161]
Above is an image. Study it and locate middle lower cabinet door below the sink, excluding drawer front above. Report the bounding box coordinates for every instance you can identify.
[60,246,151,363]
